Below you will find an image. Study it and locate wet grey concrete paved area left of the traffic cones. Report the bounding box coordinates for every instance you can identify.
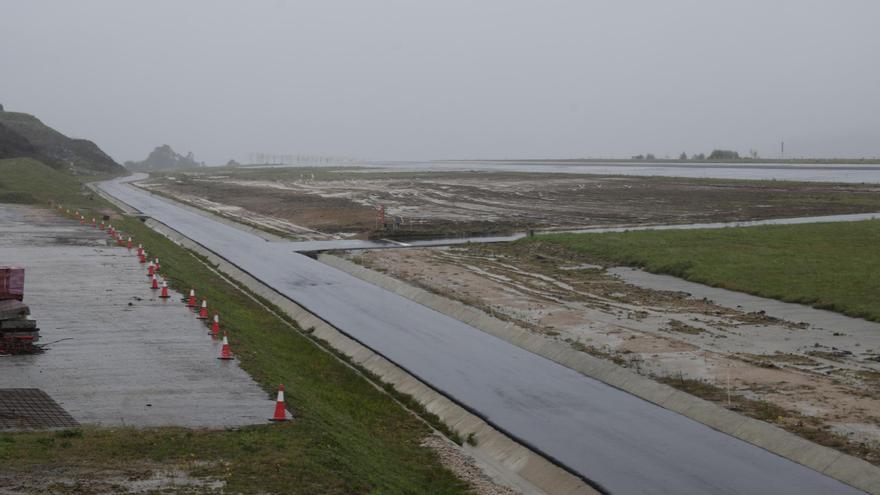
[0,205,274,427]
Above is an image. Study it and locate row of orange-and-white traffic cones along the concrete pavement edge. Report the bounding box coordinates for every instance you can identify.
[51,204,290,421]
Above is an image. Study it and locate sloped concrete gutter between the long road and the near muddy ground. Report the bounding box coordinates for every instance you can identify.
[318,253,880,494]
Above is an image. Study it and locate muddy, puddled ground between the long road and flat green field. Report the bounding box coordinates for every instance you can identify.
[348,245,880,463]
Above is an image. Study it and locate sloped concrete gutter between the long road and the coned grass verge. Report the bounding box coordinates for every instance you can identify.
[146,219,598,495]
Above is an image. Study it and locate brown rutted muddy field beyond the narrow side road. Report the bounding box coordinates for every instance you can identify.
[141,168,880,239]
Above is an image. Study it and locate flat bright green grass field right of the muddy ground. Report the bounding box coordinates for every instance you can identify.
[522,221,880,321]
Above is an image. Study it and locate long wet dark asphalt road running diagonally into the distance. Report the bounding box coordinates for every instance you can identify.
[99,178,861,494]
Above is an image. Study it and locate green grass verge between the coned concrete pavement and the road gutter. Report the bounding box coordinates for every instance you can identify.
[0,164,467,494]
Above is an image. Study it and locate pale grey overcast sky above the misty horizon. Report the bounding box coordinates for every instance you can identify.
[0,0,880,164]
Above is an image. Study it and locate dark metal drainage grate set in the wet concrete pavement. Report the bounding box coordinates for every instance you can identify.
[0,388,79,430]
